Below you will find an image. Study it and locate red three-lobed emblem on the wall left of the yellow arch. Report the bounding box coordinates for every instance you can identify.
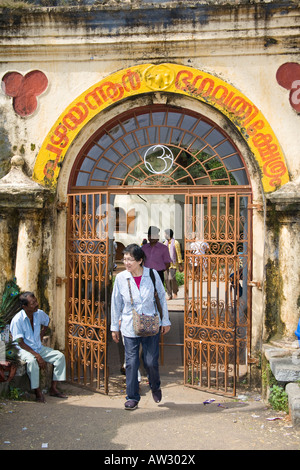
[1,70,48,117]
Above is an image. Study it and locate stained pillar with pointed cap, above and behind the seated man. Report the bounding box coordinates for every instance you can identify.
[0,155,49,291]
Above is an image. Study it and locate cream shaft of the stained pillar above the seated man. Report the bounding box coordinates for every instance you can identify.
[15,209,42,293]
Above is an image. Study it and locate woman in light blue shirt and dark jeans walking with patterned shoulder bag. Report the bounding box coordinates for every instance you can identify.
[111,244,171,410]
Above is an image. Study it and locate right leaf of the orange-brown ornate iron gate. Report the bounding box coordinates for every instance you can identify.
[184,192,252,395]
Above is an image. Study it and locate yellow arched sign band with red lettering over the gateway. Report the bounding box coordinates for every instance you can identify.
[33,64,289,193]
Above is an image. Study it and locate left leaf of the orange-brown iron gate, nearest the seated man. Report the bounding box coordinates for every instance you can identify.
[66,193,109,393]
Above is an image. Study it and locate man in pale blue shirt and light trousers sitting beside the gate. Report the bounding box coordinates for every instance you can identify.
[10,292,67,403]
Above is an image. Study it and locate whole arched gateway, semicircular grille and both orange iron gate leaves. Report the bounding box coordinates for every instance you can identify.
[66,105,252,395]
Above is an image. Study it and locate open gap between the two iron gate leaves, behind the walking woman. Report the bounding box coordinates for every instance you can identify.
[108,193,185,392]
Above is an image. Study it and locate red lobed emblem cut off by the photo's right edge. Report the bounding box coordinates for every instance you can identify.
[276,62,300,113]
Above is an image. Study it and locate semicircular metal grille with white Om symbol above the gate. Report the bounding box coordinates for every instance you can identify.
[71,105,249,189]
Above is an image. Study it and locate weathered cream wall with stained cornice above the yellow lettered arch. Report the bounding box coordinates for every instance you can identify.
[0,2,300,177]
